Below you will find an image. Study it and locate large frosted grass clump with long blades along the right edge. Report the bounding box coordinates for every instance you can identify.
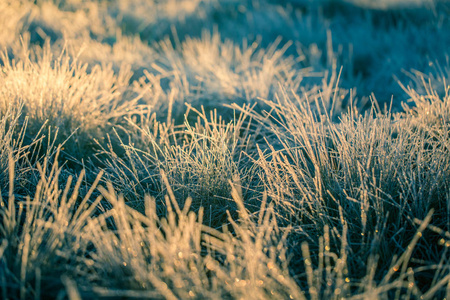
[244,75,450,295]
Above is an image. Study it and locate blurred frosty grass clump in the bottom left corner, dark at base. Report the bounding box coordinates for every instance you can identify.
[0,153,101,299]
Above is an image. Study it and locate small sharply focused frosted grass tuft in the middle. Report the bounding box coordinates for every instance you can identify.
[99,108,255,227]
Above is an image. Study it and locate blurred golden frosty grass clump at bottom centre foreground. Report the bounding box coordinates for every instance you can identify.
[78,185,301,299]
